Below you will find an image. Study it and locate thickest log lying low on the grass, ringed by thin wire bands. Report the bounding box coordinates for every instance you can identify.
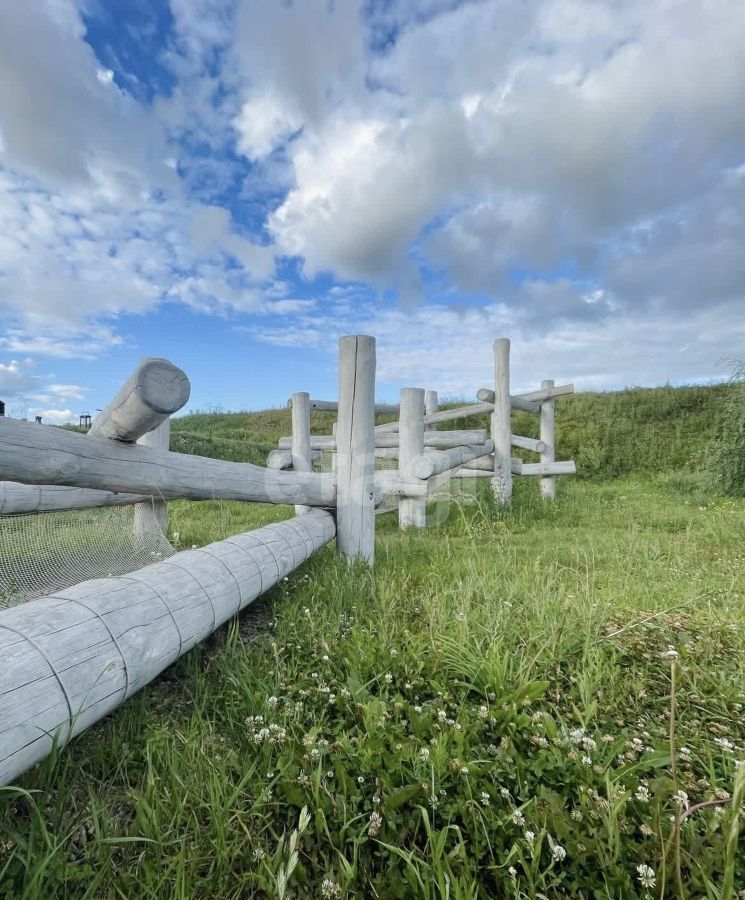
[0,510,335,784]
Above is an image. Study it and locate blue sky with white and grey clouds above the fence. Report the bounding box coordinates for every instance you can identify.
[0,0,745,422]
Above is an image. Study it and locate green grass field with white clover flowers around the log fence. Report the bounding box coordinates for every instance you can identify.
[0,388,745,900]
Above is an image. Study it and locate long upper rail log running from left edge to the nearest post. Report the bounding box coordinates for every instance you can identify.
[0,418,336,506]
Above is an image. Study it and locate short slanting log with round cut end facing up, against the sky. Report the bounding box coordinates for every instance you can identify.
[88,358,191,442]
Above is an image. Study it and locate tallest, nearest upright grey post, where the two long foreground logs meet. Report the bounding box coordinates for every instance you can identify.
[336,334,375,565]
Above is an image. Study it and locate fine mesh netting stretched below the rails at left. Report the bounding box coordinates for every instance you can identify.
[0,506,174,608]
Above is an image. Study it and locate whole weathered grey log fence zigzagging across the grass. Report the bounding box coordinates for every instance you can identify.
[0,335,576,783]
